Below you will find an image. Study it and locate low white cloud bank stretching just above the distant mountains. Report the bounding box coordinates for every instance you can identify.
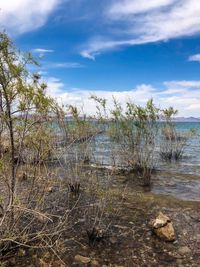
[44,78,200,117]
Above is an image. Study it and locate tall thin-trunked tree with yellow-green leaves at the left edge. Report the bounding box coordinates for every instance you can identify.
[0,33,53,216]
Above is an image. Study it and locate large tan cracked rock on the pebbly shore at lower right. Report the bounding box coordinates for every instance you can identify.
[152,212,176,241]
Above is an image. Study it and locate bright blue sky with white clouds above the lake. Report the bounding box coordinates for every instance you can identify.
[0,0,200,117]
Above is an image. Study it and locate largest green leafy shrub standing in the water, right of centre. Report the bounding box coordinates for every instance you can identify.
[106,100,159,185]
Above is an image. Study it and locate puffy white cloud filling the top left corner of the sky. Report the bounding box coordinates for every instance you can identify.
[0,0,60,34]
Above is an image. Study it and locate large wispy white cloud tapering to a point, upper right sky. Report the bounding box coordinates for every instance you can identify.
[81,0,200,59]
